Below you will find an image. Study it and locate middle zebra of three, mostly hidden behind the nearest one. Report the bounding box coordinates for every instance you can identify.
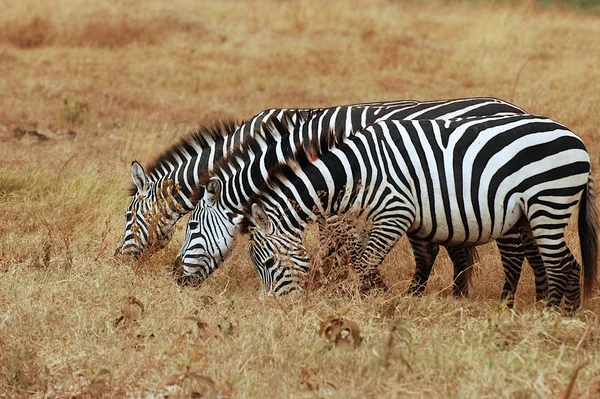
[176,98,545,302]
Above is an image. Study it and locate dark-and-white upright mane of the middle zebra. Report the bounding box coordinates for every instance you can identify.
[190,111,313,204]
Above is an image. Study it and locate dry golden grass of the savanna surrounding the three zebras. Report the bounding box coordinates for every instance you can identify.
[0,0,600,398]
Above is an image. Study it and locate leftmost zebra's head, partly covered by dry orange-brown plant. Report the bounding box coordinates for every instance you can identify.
[115,161,181,259]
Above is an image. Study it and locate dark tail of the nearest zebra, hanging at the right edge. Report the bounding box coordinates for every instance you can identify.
[577,178,598,298]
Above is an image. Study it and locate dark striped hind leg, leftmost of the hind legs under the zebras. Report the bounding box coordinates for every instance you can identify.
[496,225,525,309]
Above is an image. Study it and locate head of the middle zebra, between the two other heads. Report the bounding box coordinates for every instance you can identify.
[173,177,242,283]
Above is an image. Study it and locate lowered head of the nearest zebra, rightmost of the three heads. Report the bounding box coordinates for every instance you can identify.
[247,203,310,296]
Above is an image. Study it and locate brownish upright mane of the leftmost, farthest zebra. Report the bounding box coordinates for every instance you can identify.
[129,119,240,196]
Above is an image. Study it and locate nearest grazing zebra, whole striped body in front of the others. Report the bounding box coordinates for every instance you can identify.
[242,115,598,311]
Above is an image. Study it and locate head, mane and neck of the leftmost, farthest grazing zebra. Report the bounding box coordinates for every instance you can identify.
[115,109,308,259]
